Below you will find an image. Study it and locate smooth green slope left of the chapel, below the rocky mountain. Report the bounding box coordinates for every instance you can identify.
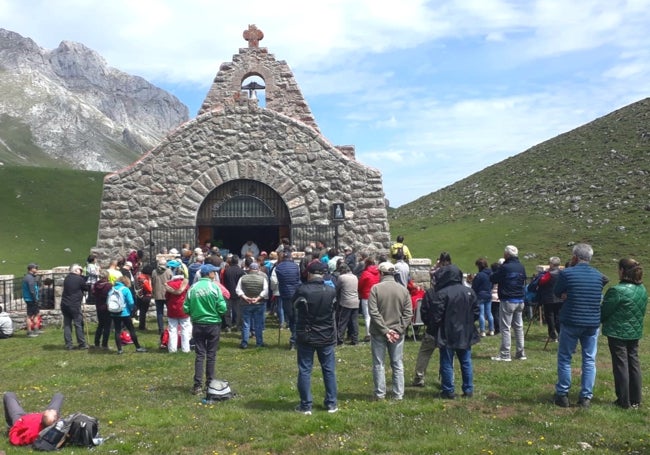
[0,165,104,276]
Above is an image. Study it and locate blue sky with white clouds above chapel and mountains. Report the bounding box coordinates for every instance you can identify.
[0,0,650,207]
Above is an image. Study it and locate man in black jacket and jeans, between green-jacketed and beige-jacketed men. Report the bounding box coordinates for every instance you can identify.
[292,261,338,415]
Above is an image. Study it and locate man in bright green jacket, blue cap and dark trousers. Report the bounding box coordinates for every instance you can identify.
[183,264,227,395]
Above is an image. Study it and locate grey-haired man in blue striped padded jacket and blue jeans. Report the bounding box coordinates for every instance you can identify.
[553,243,609,408]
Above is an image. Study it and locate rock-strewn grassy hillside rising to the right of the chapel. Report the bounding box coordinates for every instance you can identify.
[389,99,650,279]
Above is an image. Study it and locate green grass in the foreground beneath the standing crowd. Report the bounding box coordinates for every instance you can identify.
[0,318,650,455]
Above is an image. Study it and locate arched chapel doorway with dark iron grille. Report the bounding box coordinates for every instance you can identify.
[196,179,291,254]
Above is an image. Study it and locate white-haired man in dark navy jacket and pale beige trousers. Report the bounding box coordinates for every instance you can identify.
[490,245,526,362]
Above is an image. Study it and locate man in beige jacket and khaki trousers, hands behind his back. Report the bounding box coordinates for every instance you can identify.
[368,262,413,400]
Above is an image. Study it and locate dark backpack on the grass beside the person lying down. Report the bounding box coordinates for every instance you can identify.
[33,412,99,451]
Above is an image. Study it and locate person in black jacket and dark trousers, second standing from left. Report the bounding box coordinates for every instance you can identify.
[61,264,88,350]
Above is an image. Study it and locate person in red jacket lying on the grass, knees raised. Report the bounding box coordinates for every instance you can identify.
[3,392,63,446]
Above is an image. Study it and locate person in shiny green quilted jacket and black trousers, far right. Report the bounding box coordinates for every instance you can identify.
[601,258,648,409]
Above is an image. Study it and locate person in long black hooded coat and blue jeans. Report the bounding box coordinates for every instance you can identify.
[431,264,480,400]
